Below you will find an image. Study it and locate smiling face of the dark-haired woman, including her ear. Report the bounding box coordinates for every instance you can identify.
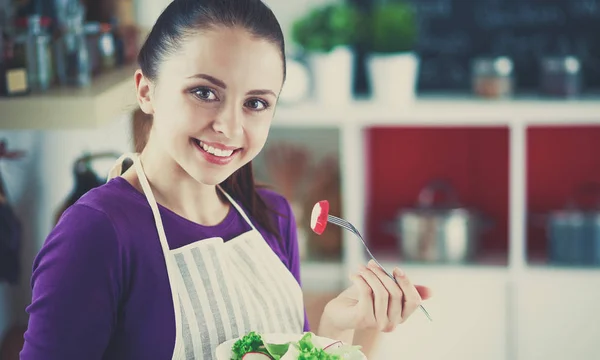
[136,27,283,185]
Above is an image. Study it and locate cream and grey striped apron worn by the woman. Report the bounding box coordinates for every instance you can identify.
[109,154,304,360]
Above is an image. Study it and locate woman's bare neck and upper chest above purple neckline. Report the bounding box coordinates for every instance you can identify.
[123,138,230,226]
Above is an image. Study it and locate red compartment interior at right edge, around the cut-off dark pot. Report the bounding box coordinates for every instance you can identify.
[526,124,600,269]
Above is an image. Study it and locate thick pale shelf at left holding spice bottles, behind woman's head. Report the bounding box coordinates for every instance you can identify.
[0,66,136,130]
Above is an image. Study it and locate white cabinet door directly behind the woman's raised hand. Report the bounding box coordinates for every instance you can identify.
[372,268,507,360]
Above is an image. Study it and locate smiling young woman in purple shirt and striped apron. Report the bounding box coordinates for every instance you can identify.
[21,0,429,360]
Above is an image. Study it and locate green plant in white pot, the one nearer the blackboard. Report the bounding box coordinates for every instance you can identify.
[365,1,419,105]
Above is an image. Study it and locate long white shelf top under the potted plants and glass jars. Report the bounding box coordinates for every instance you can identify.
[273,93,600,127]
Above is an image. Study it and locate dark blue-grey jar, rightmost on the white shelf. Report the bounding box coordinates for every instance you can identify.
[540,56,581,98]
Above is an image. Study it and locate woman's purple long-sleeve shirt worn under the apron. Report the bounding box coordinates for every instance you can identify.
[21,178,309,360]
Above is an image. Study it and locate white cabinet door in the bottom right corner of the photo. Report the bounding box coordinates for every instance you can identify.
[516,270,600,360]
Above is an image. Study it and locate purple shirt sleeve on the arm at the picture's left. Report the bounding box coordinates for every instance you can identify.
[21,204,122,360]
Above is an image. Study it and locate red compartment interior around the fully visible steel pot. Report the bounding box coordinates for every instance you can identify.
[363,126,510,263]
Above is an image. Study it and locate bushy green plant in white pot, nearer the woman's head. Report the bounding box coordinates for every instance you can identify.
[291,2,360,105]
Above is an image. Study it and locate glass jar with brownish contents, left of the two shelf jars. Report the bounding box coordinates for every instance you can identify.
[471,56,514,99]
